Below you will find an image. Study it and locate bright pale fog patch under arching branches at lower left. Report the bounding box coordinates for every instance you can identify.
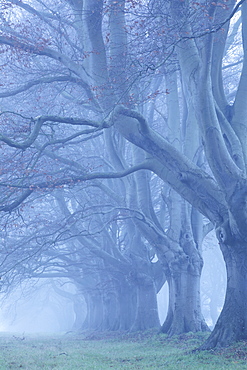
[1,284,75,333]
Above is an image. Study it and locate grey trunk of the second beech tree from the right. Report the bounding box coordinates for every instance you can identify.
[161,256,208,335]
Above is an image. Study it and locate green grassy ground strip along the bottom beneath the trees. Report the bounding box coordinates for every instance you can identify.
[0,333,247,370]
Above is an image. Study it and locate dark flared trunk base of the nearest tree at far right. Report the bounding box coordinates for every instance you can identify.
[200,240,247,350]
